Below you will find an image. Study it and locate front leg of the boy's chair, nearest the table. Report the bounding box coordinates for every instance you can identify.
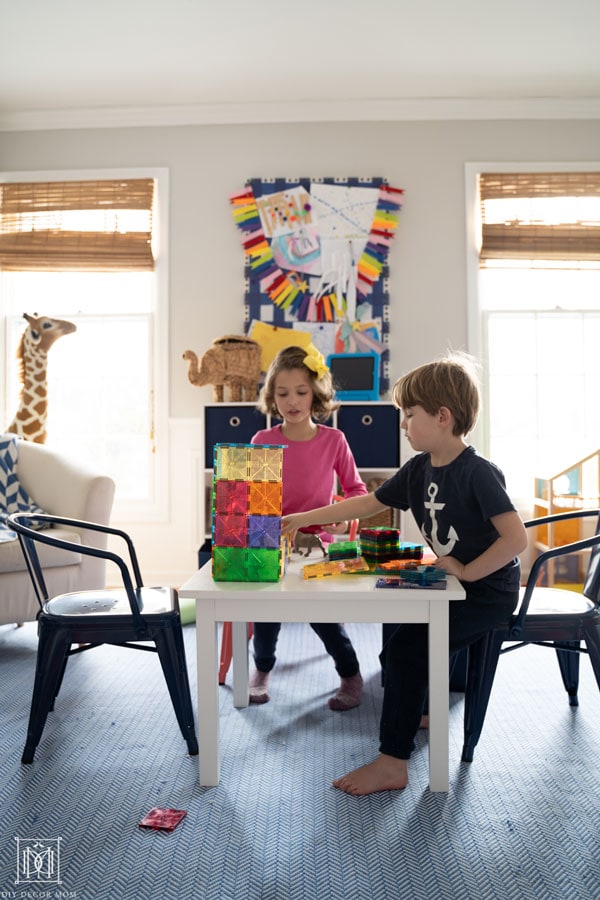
[462,631,502,762]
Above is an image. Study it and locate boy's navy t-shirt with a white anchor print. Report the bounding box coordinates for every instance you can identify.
[375,447,520,591]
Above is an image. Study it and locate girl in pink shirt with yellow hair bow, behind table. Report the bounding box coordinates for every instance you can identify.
[250,345,367,710]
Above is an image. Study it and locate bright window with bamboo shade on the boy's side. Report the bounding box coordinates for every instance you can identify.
[470,170,600,506]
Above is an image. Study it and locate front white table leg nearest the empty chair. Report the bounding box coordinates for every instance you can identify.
[196,598,219,787]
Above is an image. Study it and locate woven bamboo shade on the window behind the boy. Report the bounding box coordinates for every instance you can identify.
[479,172,600,264]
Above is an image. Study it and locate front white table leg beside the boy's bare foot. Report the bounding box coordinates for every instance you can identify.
[429,600,450,791]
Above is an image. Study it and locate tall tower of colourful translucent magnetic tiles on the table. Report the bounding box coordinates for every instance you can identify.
[212,444,284,581]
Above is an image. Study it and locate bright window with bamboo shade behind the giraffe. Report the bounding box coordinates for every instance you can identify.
[0,173,166,521]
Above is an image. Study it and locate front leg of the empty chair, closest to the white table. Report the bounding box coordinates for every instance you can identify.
[153,619,198,756]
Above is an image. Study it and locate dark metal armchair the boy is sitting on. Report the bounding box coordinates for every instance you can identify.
[462,509,600,762]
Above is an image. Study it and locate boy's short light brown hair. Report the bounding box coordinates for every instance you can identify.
[392,353,481,435]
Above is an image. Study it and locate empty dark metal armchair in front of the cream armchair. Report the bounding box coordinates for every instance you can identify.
[7,513,198,763]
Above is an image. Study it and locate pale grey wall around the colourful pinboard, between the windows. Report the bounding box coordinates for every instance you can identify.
[0,120,600,585]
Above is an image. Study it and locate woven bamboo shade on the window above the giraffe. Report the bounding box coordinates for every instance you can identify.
[0,178,154,271]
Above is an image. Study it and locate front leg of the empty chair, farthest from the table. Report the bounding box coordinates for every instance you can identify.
[21,620,71,765]
